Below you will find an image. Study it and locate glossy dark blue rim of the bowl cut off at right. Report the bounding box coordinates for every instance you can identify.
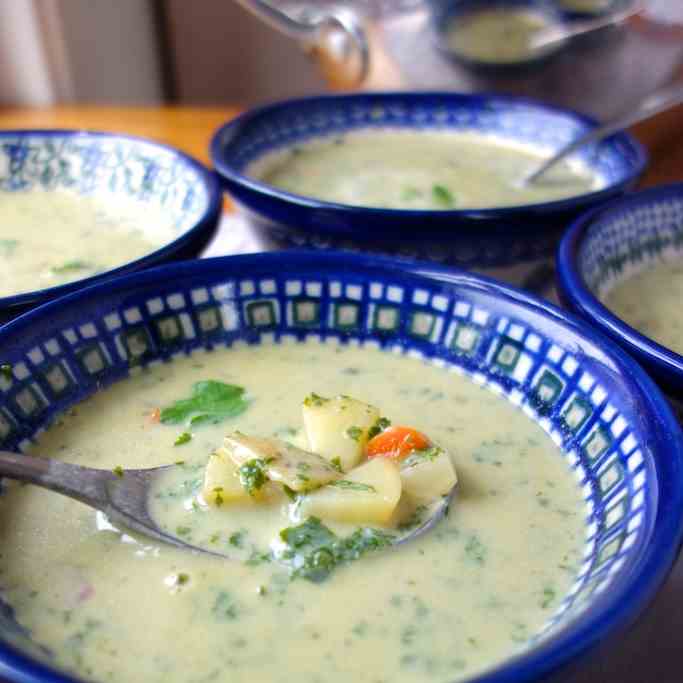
[556,182,683,387]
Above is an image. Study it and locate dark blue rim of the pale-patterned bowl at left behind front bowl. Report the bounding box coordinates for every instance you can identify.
[0,128,222,312]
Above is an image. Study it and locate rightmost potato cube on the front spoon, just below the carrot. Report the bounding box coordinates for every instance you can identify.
[401,446,458,504]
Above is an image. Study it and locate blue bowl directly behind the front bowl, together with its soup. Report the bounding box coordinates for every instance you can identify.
[211,93,645,283]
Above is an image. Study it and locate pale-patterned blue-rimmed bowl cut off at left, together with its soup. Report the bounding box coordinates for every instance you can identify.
[0,130,221,324]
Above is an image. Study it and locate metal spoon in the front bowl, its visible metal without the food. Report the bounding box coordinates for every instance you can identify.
[0,451,457,557]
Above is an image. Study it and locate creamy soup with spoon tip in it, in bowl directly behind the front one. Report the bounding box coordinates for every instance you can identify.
[252,131,601,210]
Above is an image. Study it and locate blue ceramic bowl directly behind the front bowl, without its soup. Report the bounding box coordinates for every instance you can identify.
[211,93,646,281]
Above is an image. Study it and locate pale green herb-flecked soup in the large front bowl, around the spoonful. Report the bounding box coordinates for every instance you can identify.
[0,343,585,683]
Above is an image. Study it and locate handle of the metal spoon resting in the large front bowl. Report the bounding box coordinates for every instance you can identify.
[0,451,116,510]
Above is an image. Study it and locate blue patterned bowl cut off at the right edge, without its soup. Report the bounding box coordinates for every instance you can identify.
[557,183,683,400]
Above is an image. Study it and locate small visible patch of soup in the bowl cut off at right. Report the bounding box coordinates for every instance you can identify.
[605,263,683,353]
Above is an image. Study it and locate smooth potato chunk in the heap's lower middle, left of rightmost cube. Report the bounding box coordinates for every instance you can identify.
[299,458,401,524]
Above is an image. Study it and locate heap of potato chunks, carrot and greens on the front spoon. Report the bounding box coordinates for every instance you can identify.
[190,396,457,581]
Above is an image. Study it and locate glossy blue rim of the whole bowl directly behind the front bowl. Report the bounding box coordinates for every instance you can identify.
[209,90,649,224]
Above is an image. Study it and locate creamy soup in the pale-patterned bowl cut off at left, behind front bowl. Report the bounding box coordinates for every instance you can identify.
[0,191,168,296]
